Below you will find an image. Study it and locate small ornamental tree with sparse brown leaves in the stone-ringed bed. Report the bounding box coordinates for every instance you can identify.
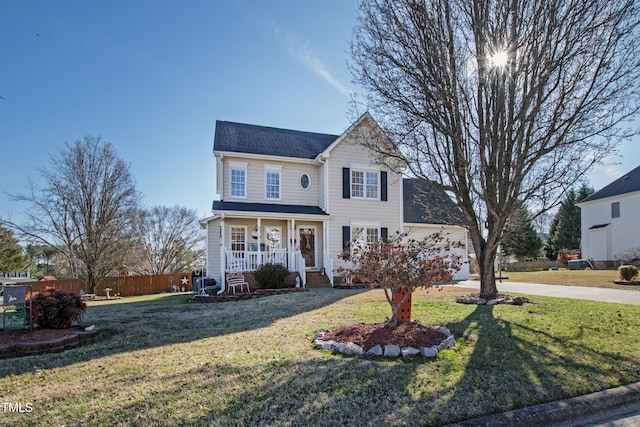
[337,231,462,328]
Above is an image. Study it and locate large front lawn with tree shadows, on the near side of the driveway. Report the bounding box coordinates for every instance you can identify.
[0,288,640,426]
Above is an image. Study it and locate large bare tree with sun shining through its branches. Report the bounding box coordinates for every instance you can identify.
[351,0,640,296]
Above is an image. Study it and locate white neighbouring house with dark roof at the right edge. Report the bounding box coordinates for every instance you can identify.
[577,167,640,268]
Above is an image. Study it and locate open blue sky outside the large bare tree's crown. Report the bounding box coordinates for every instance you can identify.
[0,0,640,226]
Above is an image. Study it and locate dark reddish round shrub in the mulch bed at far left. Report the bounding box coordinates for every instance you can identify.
[27,287,87,329]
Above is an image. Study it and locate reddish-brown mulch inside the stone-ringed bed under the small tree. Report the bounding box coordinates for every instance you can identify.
[322,322,446,351]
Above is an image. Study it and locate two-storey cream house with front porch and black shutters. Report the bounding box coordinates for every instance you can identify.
[201,113,468,285]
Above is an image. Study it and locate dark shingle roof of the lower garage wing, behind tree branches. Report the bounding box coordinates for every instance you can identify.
[402,179,466,226]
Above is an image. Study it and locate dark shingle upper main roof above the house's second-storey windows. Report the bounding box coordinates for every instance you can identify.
[213,121,338,159]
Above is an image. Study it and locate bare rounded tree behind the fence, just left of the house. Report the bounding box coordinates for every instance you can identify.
[136,206,204,274]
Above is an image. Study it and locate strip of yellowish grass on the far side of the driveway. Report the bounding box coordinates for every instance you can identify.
[502,268,640,290]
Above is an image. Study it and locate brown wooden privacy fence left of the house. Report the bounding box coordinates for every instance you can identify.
[20,273,193,297]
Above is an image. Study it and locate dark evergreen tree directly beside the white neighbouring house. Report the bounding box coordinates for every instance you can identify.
[546,184,594,260]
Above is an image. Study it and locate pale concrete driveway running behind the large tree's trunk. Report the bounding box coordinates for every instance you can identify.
[454,280,640,305]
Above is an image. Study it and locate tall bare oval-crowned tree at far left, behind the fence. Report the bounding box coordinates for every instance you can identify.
[8,135,139,293]
